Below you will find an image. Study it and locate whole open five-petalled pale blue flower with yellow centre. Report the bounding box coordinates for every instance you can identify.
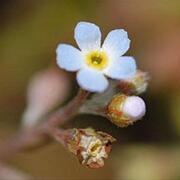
[56,22,136,92]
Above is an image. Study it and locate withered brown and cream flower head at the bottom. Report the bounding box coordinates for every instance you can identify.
[67,128,115,168]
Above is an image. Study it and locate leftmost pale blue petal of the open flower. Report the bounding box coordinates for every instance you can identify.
[56,44,83,71]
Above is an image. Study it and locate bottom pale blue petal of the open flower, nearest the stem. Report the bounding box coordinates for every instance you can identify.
[77,68,108,92]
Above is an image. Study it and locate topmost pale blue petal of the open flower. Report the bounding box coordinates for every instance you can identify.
[74,22,101,50]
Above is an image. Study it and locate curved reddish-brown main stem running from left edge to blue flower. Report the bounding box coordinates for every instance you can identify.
[0,89,90,161]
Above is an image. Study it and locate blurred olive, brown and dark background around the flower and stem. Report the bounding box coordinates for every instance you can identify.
[0,0,180,180]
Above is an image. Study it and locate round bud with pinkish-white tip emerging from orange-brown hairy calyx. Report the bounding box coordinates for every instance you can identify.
[106,94,146,127]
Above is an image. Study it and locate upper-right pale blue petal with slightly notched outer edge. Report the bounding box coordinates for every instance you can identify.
[102,29,130,57]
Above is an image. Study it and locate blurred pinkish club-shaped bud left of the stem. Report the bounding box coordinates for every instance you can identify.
[22,69,70,127]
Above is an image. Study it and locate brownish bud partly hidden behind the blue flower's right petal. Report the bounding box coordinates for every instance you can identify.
[119,70,149,95]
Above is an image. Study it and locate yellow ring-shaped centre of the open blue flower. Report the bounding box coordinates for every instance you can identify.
[86,51,108,70]
